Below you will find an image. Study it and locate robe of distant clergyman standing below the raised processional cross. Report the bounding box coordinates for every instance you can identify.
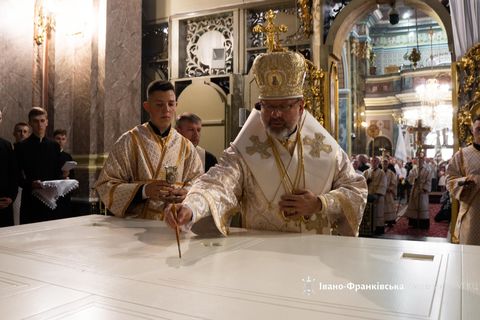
[405,166,432,220]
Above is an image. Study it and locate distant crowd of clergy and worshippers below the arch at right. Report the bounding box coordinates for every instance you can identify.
[351,154,450,234]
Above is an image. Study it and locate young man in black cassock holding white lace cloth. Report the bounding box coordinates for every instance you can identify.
[15,107,71,224]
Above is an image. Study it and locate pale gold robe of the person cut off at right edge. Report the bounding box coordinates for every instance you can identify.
[446,146,480,245]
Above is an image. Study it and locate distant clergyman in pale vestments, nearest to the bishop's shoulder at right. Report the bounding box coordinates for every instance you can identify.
[363,157,387,234]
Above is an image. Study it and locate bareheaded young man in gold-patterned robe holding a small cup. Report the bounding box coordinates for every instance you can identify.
[95,81,203,220]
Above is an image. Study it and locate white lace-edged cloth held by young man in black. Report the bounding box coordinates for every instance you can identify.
[32,179,78,210]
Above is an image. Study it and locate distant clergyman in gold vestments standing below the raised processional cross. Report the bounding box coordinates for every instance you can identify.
[405,157,432,229]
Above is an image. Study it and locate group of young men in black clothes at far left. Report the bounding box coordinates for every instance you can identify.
[0,107,74,227]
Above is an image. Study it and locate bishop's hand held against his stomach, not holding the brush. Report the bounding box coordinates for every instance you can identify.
[278,189,322,218]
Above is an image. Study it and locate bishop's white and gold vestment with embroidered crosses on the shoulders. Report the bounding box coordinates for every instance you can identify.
[183,110,367,236]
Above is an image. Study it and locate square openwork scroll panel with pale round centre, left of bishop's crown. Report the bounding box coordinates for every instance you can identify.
[184,13,234,77]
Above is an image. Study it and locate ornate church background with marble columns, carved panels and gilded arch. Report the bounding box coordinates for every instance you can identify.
[0,0,466,240]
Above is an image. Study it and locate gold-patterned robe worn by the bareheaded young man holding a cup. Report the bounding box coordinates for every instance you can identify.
[95,123,203,219]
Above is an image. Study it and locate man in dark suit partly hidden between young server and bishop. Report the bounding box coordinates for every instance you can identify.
[175,113,217,172]
